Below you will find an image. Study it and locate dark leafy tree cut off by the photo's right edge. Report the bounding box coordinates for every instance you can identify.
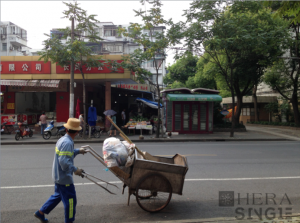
[264,1,300,126]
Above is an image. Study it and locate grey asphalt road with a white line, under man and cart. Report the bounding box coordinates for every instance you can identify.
[0,141,300,223]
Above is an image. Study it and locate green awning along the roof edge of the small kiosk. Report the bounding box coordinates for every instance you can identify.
[167,94,222,101]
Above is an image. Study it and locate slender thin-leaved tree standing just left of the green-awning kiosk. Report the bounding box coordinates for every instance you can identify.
[118,0,179,138]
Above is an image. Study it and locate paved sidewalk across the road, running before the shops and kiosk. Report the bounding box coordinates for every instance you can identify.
[1,126,300,145]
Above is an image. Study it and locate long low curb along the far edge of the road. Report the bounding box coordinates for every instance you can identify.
[1,138,293,146]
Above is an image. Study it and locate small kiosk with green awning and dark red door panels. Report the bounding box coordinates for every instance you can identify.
[163,89,222,134]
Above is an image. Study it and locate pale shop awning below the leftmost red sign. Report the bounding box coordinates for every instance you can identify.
[1,80,60,88]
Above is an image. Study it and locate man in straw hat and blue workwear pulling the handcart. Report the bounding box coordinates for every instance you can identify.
[34,118,86,223]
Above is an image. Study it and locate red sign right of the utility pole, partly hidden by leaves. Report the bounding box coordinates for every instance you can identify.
[56,60,124,74]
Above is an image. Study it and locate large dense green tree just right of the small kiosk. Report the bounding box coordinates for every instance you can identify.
[185,1,286,137]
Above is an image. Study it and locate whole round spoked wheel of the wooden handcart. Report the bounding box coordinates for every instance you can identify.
[135,173,172,212]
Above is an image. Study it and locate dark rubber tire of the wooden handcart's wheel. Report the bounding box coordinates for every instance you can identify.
[135,173,172,213]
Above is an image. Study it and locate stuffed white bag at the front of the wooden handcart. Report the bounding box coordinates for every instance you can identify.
[102,137,128,167]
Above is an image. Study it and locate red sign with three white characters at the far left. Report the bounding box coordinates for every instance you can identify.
[0,61,51,74]
